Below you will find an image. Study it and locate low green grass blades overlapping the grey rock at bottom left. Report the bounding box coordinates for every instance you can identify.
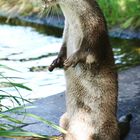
[0,107,67,140]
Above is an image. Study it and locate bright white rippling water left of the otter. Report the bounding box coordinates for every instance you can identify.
[0,25,65,105]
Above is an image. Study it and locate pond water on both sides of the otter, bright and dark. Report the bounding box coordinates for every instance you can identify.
[0,25,140,107]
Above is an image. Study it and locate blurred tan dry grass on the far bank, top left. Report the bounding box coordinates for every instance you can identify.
[0,0,42,17]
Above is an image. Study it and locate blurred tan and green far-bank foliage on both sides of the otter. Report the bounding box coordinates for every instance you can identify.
[0,0,140,29]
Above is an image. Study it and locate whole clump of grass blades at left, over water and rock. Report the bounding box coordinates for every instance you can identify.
[0,64,67,140]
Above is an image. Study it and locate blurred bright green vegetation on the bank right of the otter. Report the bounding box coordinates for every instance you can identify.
[98,0,140,29]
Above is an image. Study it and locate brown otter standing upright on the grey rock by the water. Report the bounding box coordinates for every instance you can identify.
[45,0,130,140]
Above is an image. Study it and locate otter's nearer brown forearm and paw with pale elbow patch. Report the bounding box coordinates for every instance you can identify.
[64,51,95,68]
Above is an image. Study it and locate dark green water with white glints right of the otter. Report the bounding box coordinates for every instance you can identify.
[111,38,140,70]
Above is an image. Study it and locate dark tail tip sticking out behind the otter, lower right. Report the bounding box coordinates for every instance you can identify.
[118,114,132,140]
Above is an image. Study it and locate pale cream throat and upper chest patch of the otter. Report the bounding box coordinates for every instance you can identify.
[61,5,83,57]
